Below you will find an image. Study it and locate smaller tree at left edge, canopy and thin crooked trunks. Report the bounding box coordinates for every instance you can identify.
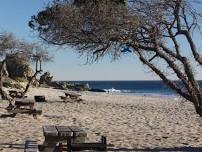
[0,33,51,101]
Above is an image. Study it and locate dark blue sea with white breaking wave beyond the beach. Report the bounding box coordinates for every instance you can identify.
[65,81,202,97]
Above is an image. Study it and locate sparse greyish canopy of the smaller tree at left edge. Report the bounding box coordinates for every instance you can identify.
[0,33,51,63]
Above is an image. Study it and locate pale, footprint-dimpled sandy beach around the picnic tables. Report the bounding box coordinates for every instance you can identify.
[0,88,202,152]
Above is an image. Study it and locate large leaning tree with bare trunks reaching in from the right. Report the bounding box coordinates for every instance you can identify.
[29,0,202,116]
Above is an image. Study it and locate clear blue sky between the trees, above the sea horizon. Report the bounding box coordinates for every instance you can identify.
[0,0,201,80]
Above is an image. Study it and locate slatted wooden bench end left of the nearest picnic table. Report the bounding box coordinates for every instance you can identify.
[24,140,39,152]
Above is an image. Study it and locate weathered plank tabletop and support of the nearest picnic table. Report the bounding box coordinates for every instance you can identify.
[43,125,87,152]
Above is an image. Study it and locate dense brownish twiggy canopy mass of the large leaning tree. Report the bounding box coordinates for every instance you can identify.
[29,0,138,60]
